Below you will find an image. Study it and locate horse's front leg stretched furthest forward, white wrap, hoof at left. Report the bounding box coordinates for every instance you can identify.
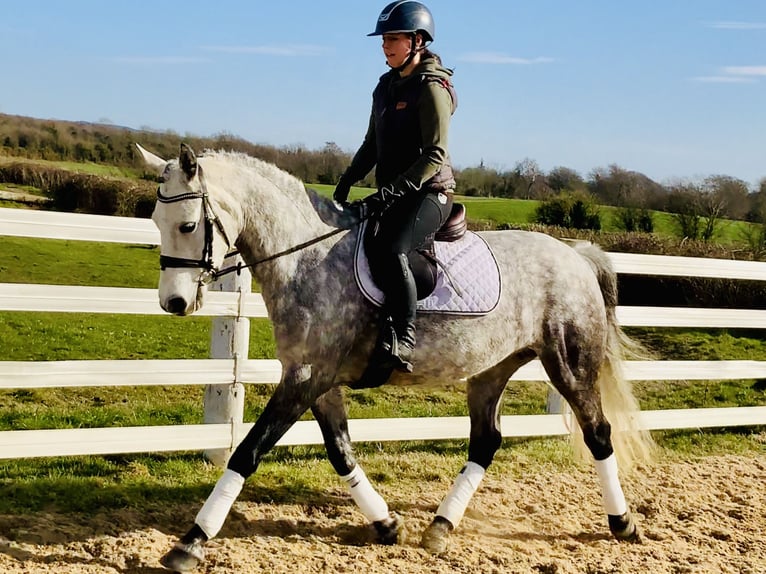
[160,365,332,572]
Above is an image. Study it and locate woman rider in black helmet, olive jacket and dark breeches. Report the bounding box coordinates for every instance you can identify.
[333,0,457,372]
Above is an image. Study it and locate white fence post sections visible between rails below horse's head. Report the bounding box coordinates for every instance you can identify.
[204,255,252,467]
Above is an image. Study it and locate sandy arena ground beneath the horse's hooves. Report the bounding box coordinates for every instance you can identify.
[0,453,766,574]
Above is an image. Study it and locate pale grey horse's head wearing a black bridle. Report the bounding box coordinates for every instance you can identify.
[136,144,236,315]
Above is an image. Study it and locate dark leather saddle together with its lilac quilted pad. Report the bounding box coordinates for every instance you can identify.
[354,203,508,315]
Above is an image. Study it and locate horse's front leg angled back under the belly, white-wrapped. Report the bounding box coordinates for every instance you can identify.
[311,387,403,544]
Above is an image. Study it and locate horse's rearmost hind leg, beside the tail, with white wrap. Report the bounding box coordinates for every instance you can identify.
[540,335,640,542]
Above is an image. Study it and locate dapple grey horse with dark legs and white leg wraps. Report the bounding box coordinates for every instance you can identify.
[137,144,651,572]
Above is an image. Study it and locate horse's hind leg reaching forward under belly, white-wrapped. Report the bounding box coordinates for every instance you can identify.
[421,349,535,554]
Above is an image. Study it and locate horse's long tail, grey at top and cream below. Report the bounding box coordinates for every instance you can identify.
[573,242,655,470]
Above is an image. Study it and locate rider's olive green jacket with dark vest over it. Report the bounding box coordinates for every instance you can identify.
[343,55,457,196]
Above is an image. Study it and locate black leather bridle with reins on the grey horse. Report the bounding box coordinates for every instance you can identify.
[157,167,356,285]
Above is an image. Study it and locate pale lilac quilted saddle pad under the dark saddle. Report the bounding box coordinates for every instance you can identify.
[354,221,501,315]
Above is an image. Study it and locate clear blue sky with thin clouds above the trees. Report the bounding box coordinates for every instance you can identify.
[0,0,766,186]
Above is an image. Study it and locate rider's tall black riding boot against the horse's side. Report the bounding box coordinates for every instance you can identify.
[386,253,418,373]
